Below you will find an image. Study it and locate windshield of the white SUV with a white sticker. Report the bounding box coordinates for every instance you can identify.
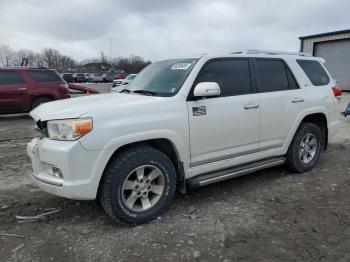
[128,58,198,96]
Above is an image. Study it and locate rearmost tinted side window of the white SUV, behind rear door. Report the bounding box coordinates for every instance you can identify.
[297,60,330,86]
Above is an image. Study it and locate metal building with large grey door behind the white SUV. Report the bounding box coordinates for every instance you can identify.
[299,29,350,90]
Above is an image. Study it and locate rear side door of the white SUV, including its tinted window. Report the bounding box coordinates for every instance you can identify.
[254,58,307,150]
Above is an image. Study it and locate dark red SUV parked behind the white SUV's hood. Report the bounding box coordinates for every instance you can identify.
[0,67,70,114]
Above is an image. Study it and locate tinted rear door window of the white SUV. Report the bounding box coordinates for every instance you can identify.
[256,59,289,92]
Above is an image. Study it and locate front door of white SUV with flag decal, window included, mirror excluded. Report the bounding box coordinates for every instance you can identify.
[187,58,260,166]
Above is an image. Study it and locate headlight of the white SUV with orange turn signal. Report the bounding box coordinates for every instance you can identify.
[47,118,92,141]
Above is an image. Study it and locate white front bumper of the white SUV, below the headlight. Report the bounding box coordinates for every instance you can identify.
[27,138,101,200]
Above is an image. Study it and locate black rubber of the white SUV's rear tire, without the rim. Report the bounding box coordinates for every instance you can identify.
[286,122,325,173]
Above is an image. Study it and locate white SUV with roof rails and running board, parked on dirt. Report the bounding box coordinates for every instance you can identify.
[27,51,339,224]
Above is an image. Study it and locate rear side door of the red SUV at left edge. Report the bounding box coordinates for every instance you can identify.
[0,70,28,114]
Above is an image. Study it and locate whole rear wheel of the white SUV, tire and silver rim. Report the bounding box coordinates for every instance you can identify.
[286,122,324,173]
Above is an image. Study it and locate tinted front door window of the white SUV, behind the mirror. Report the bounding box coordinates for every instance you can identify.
[195,59,251,96]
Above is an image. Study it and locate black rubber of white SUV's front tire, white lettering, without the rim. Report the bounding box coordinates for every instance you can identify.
[99,146,176,225]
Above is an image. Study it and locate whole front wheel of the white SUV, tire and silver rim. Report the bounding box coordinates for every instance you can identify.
[100,146,176,224]
